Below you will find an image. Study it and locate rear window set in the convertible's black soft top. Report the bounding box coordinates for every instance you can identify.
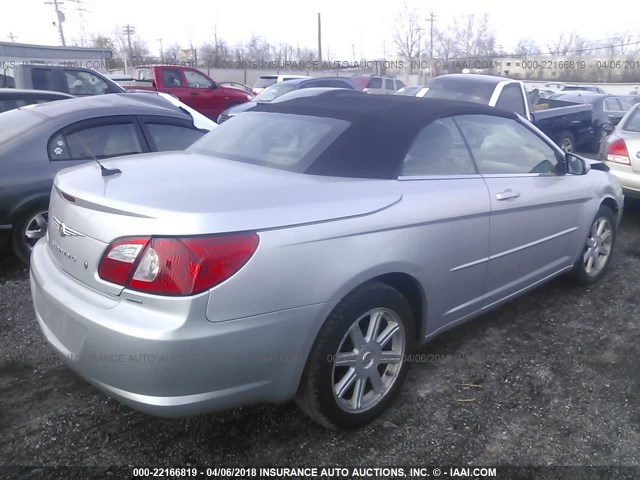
[187,112,350,173]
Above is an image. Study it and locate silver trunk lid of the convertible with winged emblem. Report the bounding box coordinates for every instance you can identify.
[47,152,401,295]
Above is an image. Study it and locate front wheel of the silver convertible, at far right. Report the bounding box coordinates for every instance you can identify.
[573,205,617,285]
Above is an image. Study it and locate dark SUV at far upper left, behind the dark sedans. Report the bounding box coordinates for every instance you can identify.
[5,64,125,96]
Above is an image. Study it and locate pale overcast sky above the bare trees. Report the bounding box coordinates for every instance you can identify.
[0,0,640,60]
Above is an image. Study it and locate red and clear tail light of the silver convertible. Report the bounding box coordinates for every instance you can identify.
[98,233,259,296]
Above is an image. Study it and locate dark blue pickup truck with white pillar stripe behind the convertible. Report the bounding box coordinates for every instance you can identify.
[425,74,592,152]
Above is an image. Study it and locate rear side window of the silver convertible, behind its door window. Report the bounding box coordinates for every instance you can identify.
[400,118,478,176]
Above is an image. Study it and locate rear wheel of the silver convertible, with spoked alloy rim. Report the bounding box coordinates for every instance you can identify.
[296,282,415,429]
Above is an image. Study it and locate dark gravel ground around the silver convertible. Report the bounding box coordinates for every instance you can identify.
[0,201,640,478]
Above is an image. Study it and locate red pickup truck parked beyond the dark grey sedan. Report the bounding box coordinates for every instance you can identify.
[123,65,252,120]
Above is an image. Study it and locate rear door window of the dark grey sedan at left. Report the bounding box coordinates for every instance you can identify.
[48,122,144,160]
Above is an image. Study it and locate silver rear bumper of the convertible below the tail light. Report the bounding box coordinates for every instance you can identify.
[31,241,330,416]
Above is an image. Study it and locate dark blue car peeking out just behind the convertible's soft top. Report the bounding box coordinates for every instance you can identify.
[218,77,358,124]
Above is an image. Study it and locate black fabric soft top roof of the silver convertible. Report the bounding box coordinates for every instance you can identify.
[253,90,517,178]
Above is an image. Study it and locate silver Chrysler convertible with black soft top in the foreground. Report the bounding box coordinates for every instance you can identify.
[31,90,623,428]
